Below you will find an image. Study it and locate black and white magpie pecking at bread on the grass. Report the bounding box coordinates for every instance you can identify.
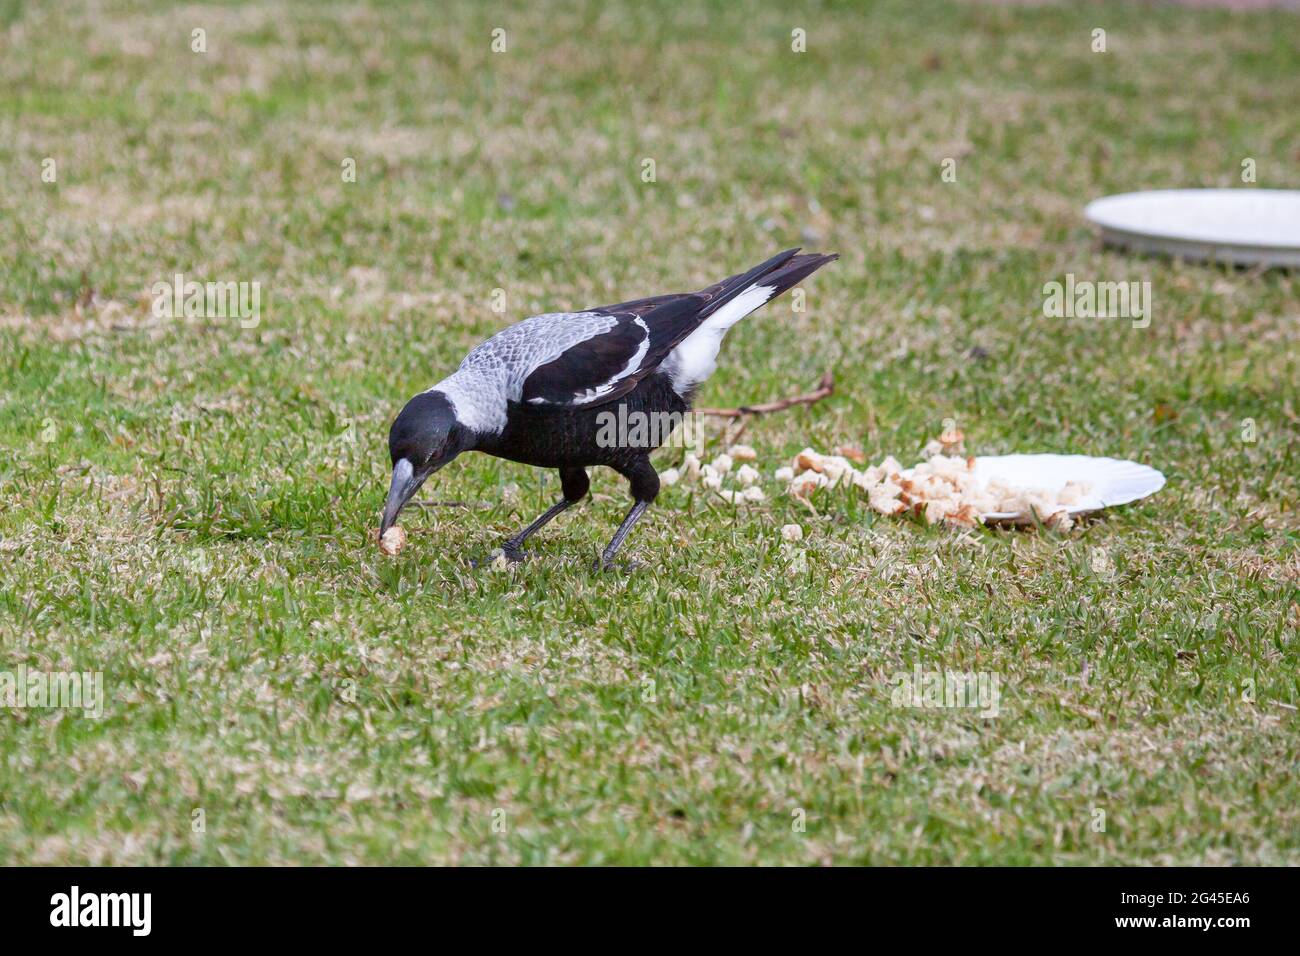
[380,248,839,568]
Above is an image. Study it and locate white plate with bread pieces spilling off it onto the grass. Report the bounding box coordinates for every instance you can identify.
[972,455,1165,523]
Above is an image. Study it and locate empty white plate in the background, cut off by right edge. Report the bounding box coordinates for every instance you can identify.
[1084,189,1300,267]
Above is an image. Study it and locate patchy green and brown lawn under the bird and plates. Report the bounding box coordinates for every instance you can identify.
[0,0,1300,864]
